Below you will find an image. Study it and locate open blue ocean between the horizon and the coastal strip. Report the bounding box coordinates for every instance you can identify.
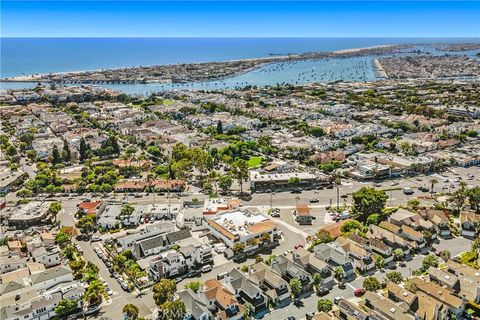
[0,38,478,78]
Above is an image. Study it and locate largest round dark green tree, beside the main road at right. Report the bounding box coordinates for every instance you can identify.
[352,187,388,221]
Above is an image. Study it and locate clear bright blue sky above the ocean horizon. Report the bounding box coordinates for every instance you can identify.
[1,0,480,38]
